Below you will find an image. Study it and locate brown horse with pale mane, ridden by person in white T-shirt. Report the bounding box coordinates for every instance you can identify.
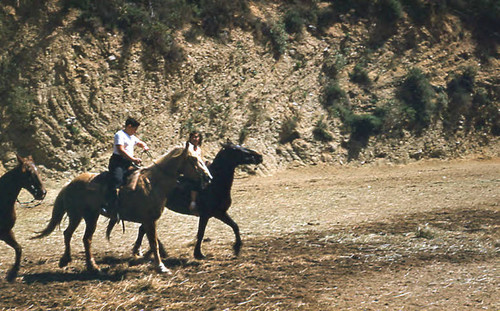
[35,144,201,272]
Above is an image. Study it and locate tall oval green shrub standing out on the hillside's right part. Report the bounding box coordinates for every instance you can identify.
[397,68,435,132]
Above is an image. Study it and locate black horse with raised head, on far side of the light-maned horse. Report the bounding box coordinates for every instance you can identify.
[133,143,262,259]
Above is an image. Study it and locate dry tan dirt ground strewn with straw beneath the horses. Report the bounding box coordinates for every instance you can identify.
[0,158,500,310]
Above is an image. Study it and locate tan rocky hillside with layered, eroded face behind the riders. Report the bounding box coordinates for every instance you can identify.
[0,0,500,177]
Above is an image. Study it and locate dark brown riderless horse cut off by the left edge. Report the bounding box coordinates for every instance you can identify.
[0,156,47,282]
